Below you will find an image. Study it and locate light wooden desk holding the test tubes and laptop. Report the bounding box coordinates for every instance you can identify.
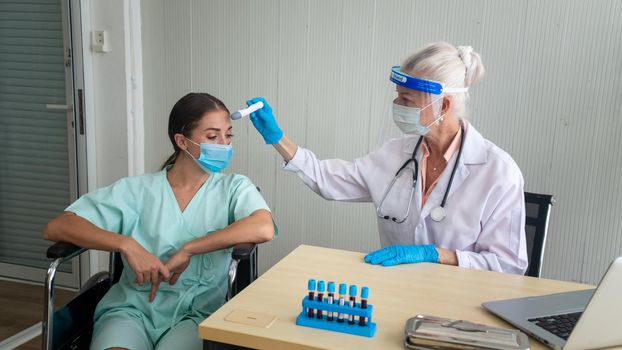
[199,245,594,350]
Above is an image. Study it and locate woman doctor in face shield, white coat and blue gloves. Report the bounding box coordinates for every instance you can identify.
[247,42,527,274]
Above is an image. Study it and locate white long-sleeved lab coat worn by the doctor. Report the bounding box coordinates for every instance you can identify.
[284,121,527,274]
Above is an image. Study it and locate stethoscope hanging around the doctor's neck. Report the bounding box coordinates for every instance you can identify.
[376,123,465,224]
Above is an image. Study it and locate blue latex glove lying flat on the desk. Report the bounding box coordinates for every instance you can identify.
[365,244,438,266]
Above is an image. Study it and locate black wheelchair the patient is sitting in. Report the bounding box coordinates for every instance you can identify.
[41,242,257,350]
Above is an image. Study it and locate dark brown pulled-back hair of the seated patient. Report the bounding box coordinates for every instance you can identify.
[162,92,229,169]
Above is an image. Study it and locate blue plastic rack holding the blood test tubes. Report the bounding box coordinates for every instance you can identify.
[296,284,376,338]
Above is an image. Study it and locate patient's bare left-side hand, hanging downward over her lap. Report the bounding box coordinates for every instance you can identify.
[121,237,171,285]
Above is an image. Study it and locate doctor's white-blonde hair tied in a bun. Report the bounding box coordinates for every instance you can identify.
[402,41,484,118]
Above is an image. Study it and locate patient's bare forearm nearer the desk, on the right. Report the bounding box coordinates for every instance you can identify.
[182,209,274,255]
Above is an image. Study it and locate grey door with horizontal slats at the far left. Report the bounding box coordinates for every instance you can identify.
[0,0,81,287]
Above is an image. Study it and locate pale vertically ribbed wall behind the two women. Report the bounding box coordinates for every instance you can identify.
[142,0,622,283]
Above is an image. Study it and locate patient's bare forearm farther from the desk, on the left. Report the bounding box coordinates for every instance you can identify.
[43,212,128,252]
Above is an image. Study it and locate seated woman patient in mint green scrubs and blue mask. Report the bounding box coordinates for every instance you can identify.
[43,93,275,349]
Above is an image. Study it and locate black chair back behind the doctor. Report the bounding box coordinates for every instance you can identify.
[525,192,555,277]
